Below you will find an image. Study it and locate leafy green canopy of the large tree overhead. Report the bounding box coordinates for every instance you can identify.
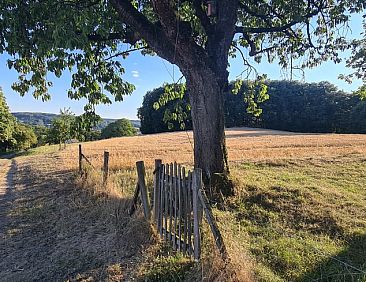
[0,0,366,111]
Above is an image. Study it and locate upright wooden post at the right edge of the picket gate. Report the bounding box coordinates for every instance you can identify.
[192,168,202,261]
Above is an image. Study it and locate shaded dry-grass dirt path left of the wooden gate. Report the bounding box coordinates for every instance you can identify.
[0,154,153,281]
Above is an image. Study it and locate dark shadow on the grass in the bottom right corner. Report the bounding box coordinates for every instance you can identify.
[300,234,366,282]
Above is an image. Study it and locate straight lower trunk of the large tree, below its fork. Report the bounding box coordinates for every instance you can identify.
[185,69,228,187]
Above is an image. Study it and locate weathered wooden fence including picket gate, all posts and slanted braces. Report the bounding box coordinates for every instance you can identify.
[79,148,228,260]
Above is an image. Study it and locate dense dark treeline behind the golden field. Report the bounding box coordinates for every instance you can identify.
[138,81,366,134]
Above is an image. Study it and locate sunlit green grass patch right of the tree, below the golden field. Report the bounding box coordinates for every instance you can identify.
[222,157,366,281]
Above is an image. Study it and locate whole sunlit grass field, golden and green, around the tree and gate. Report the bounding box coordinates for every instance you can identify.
[0,128,366,281]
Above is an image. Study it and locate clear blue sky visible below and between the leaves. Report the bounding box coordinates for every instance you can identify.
[0,15,362,119]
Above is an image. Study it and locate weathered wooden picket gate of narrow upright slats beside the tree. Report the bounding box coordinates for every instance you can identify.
[153,160,202,260]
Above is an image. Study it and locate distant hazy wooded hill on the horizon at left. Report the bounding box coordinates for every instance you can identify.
[12,112,141,129]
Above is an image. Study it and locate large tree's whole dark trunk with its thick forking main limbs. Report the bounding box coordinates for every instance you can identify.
[111,0,239,196]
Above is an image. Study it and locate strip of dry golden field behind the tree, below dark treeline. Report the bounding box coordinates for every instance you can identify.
[60,128,366,170]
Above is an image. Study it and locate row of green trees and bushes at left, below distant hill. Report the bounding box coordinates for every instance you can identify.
[0,88,137,152]
